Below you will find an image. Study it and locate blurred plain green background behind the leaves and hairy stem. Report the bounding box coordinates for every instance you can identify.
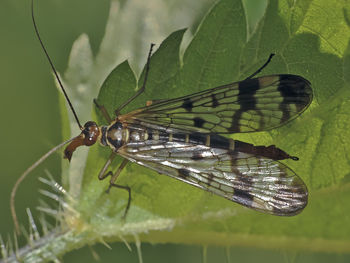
[0,0,350,262]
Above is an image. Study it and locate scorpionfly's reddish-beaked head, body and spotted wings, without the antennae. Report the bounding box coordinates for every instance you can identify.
[65,70,312,216]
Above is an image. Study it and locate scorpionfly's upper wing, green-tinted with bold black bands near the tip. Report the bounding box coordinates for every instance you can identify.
[120,75,312,134]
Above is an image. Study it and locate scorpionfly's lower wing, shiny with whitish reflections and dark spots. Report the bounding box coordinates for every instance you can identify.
[118,140,308,216]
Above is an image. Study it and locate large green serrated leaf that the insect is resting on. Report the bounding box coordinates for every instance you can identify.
[12,0,350,260]
